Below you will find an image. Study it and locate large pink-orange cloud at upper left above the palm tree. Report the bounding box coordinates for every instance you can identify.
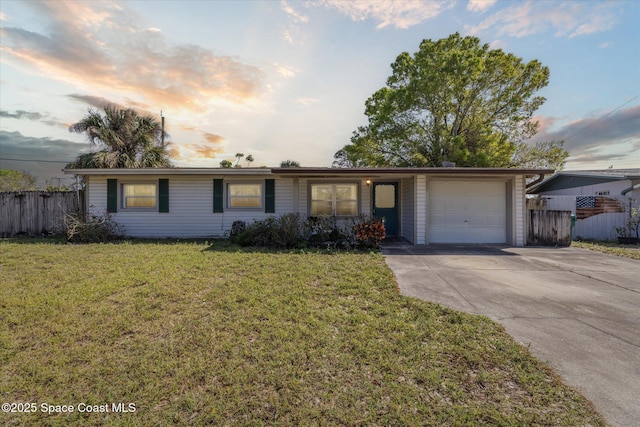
[0,1,264,111]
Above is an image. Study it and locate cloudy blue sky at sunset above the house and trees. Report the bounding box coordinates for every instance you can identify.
[0,0,640,187]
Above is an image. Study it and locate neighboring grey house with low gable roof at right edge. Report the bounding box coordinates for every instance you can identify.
[527,169,640,199]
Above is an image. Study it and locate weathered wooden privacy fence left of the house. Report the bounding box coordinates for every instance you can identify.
[0,191,85,237]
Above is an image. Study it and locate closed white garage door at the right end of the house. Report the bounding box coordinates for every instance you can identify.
[429,181,507,243]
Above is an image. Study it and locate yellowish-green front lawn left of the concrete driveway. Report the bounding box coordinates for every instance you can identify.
[0,239,604,426]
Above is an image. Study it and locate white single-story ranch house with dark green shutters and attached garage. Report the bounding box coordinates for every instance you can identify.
[65,167,553,246]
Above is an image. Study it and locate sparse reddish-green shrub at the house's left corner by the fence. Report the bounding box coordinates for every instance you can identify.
[64,212,125,243]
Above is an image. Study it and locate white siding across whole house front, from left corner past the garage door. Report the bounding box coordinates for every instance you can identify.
[86,170,526,246]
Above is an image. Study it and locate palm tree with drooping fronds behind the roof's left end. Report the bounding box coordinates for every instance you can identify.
[67,105,171,169]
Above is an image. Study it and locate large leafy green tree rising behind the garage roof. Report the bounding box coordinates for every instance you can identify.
[334,33,568,168]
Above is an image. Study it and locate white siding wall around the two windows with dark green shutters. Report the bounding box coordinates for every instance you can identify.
[87,175,294,238]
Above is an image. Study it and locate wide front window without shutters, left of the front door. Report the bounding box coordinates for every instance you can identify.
[311,184,358,216]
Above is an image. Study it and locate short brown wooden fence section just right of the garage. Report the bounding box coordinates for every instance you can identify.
[527,210,571,246]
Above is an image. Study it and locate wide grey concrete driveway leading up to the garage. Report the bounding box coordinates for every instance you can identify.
[383,245,640,426]
